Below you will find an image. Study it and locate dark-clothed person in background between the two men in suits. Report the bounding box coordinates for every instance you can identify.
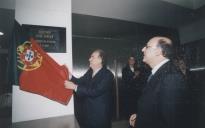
[122,56,146,118]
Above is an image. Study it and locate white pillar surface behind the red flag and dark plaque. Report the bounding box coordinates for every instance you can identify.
[12,0,74,122]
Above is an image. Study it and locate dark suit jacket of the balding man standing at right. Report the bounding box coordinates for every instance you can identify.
[136,62,189,128]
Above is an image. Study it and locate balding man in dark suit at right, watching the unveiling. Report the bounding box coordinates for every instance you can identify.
[130,37,189,128]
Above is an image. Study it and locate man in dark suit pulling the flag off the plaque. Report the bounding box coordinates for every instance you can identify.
[65,49,114,128]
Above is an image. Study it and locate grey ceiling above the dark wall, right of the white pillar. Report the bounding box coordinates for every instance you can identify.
[72,0,205,28]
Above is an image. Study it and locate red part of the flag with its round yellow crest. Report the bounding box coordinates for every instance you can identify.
[17,39,72,105]
